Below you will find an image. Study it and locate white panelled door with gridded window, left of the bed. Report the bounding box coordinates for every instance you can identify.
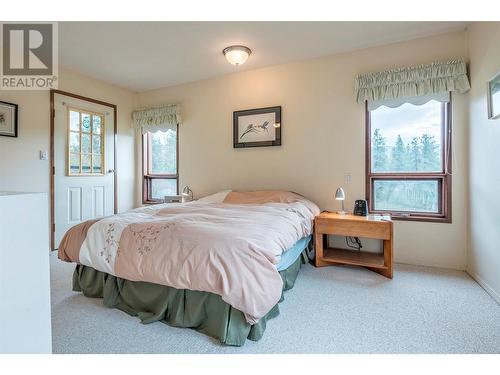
[54,94,115,249]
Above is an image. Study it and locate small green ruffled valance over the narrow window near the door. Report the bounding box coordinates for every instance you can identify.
[132,104,181,134]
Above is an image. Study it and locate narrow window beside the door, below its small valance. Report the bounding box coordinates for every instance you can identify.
[143,128,179,203]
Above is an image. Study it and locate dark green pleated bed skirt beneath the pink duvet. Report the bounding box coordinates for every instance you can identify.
[73,250,308,346]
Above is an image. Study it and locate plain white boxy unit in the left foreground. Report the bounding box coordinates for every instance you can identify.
[0,192,52,354]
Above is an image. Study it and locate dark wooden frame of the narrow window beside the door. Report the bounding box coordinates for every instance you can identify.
[142,124,179,204]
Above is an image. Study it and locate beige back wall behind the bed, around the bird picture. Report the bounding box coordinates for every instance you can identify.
[136,32,468,269]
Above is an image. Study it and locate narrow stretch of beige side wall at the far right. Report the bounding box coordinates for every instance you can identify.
[467,22,500,303]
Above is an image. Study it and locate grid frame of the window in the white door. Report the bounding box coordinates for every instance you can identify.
[66,106,106,177]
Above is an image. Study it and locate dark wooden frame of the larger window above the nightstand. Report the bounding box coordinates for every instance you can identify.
[365,97,452,223]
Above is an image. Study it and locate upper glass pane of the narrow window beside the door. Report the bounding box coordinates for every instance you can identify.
[150,129,177,174]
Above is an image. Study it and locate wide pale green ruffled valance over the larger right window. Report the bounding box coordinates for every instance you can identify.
[356,59,470,103]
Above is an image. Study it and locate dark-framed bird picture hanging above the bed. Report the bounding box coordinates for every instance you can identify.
[233,106,283,148]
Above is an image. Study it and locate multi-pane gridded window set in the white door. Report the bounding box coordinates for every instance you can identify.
[68,108,104,176]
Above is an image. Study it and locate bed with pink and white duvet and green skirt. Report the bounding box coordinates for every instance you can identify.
[58,190,319,346]
